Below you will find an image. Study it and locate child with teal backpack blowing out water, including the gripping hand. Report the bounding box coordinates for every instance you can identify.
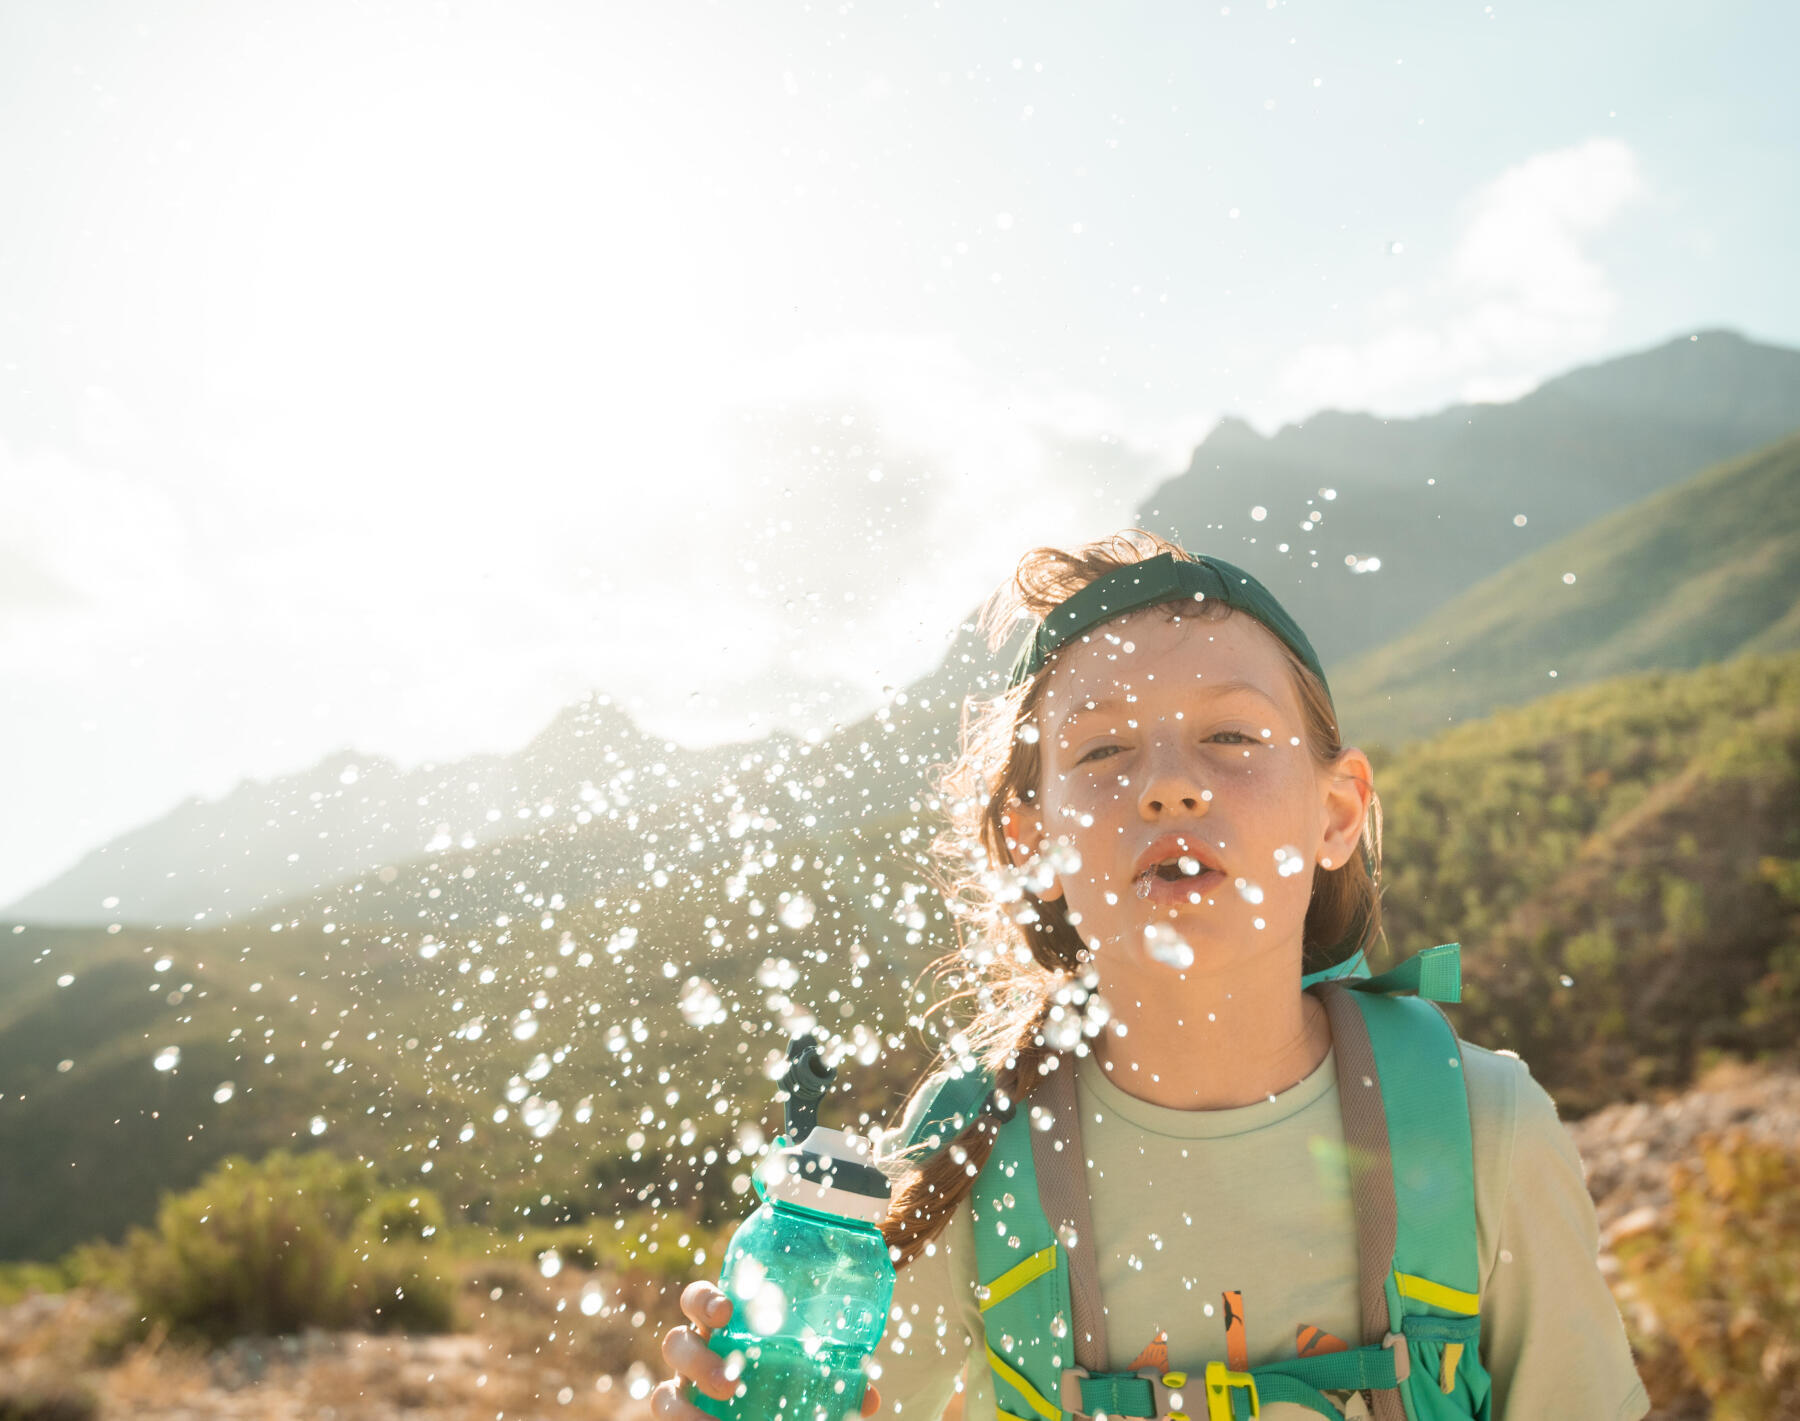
[653,529,1649,1421]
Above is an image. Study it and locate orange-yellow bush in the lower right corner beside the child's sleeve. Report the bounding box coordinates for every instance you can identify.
[1616,1131,1800,1421]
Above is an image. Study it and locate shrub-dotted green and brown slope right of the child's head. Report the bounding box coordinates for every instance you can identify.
[1375,654,1800,1113]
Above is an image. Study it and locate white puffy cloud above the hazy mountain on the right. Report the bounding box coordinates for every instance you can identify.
[1258,139,1645,423]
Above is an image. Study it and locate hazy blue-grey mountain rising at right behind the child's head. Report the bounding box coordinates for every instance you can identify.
[1139,331,1800,674]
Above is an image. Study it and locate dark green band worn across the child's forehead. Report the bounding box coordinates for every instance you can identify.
[1006,553,1332,697]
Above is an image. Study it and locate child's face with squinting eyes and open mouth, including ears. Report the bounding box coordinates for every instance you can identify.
[1012,607,1368,974]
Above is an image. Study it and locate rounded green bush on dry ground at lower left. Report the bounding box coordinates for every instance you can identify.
[126,1151,454,1342]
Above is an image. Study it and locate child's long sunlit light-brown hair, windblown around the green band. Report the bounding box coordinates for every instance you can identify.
[882,528,1381,1266]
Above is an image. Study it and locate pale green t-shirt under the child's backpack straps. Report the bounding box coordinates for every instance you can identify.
[877,1043,1651,1421]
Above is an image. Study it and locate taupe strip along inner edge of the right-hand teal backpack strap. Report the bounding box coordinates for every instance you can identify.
[1312,982,1406,1421]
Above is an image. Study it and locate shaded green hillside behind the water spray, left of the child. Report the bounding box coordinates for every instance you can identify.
[0,803,947,1259]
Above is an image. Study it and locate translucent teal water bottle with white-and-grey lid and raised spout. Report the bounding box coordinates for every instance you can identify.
[689,1036,895,1421]
